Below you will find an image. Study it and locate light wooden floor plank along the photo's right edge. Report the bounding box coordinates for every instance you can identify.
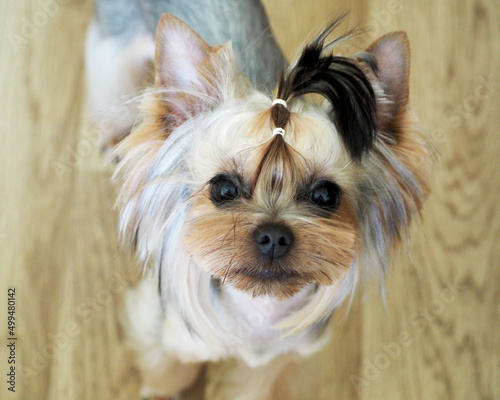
[362,0,500,399]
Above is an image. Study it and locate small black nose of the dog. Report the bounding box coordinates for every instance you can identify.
[253,224,294,258]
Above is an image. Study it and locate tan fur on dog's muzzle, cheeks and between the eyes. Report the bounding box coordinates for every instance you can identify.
[185,113,357,299]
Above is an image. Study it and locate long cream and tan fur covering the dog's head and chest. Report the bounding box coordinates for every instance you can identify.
[116,16,431,394]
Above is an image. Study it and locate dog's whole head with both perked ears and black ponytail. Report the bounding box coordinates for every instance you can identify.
[115,16,429,299]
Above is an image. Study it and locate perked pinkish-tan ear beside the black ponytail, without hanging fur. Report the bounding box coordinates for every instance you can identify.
[366,31,410,133]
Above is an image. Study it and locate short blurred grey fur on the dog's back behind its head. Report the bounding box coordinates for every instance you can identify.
[91,0,286,91]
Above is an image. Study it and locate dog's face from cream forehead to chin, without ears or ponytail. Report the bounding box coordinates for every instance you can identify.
[185,101,357,298]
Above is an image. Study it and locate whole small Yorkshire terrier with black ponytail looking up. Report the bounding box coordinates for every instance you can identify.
[87,0,432,400]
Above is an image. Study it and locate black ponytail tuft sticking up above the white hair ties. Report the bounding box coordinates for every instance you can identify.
[277,16,377,160]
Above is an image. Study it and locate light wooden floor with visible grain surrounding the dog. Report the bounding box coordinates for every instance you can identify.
[0,0,500,400]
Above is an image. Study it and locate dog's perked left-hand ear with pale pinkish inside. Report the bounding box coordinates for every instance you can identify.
[155,14,234,122]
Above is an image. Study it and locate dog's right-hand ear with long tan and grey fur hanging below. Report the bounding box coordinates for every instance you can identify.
[356,32,434,287]
